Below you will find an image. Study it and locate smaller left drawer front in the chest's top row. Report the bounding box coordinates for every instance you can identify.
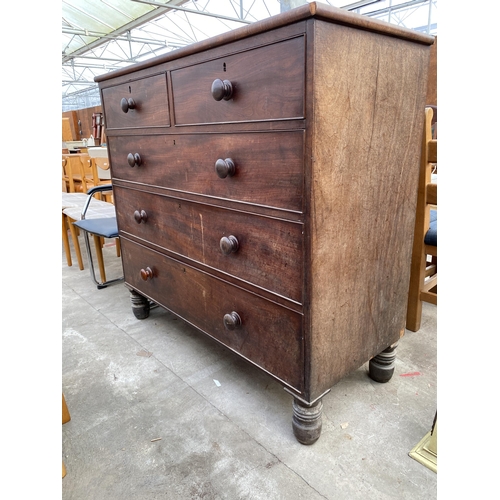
[102,73,170,129]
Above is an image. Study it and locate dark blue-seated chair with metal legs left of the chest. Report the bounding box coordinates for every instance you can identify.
[73,184,124,289]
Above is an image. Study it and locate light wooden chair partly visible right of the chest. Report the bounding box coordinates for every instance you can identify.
[406,108,437,332]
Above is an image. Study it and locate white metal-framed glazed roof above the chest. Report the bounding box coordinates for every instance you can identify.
[62,0,437,111]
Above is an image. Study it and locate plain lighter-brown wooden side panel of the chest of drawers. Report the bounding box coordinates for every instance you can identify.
[307,22,429,400]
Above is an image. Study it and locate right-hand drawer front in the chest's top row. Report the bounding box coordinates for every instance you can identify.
[171,36,305,125]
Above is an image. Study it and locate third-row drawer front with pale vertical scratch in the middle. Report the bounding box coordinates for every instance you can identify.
[114,187,303,303]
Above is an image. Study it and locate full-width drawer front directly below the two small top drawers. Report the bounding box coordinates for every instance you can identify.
[108,131,304,212]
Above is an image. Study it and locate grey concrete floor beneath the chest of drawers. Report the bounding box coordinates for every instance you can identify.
[62,241,437,500]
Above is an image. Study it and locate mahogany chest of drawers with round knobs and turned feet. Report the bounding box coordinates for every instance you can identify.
[96,3,433,444]
